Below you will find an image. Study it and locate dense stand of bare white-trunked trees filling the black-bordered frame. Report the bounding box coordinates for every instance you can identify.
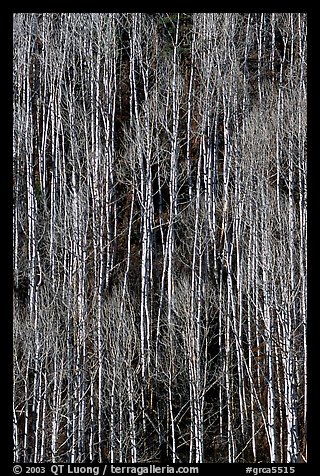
[13,13,307,463]
